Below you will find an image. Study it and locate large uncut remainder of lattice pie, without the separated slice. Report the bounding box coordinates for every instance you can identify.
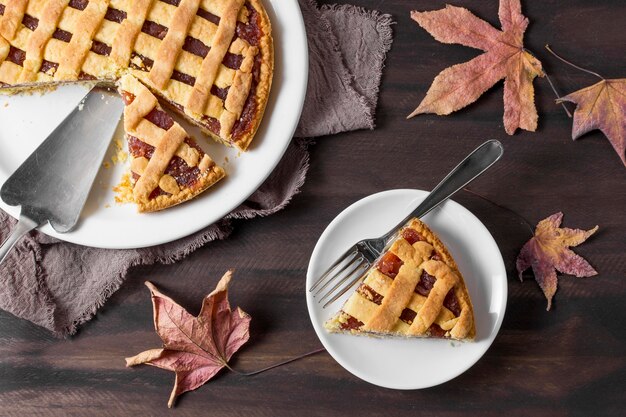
[0,0,274,150]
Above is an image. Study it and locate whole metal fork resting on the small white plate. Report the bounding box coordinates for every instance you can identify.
[309,140,504,308]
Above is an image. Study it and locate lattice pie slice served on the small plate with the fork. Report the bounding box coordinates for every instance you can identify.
[324,219,476,341]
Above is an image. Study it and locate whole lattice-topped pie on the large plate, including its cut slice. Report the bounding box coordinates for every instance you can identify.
[0,0,274,211]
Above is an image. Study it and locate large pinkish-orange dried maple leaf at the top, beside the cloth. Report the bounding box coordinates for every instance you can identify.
[408,0,544,135]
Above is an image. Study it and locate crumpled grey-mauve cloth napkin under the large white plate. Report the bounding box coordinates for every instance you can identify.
[0,0,392,337]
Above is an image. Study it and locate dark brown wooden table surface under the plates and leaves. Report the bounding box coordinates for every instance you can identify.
[0,0,626,417]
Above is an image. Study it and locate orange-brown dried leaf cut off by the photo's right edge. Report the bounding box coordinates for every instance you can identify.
[557,78,626,165]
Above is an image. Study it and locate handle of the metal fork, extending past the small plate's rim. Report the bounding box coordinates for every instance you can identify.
[385,140,504,241]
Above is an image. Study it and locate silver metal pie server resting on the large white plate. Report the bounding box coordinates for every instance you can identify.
[0,86,124,263]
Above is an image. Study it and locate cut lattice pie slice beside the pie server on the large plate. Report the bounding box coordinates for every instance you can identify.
[119,75,225,212]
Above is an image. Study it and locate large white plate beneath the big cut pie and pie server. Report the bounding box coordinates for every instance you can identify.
[0,0,308,248]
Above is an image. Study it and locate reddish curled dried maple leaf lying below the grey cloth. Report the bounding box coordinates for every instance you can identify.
[126,271,250,408]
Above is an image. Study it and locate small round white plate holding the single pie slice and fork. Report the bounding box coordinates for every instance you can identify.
[306,190,507,389]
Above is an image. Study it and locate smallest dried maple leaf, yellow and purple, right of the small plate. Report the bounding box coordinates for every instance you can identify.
[517,212,598,310]
